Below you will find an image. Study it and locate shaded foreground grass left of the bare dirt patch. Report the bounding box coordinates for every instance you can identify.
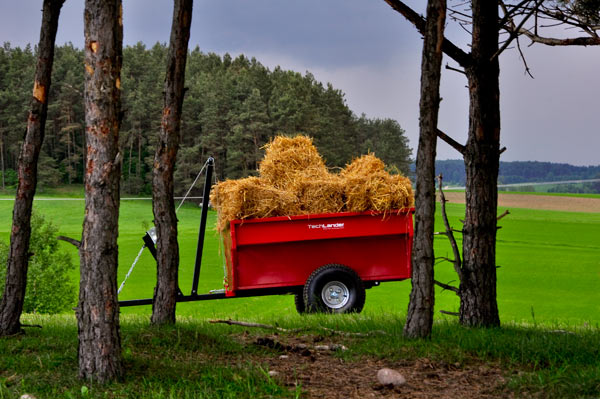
[0,316,296,398]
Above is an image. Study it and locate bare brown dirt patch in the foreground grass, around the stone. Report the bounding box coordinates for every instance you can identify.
[242,335,512,399]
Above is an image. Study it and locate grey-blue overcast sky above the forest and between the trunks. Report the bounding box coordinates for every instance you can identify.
[0,0,600,165]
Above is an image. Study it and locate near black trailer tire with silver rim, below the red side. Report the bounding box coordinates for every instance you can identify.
[304,264,365,313]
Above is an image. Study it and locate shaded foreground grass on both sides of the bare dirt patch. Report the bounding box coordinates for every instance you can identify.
[0,314,600,398]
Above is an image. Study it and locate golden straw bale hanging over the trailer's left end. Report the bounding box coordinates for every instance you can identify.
[210,177,299,231]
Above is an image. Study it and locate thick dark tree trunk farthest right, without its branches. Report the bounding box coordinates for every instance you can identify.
[459,0,500,327]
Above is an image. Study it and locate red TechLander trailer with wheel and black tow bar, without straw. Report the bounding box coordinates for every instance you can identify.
[119,160,414,313]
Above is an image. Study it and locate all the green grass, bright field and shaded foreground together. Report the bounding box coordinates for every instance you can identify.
[0,193,600,399]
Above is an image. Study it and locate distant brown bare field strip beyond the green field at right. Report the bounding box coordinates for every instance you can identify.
[444,192,600,213]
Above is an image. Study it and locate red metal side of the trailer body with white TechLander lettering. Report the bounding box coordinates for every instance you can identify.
[227,210,413,295]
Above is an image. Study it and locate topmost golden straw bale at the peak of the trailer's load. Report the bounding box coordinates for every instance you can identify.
[258,135,329,189]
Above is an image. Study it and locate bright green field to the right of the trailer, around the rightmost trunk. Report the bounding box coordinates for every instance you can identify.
[435,204,600,326]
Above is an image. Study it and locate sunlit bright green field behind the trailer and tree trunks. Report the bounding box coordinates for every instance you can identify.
[0,196,600,326]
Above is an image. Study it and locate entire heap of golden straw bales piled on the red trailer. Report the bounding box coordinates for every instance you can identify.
[210,136,414,232]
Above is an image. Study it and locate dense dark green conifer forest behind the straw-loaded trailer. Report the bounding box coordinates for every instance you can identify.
[0,43,412,194]
